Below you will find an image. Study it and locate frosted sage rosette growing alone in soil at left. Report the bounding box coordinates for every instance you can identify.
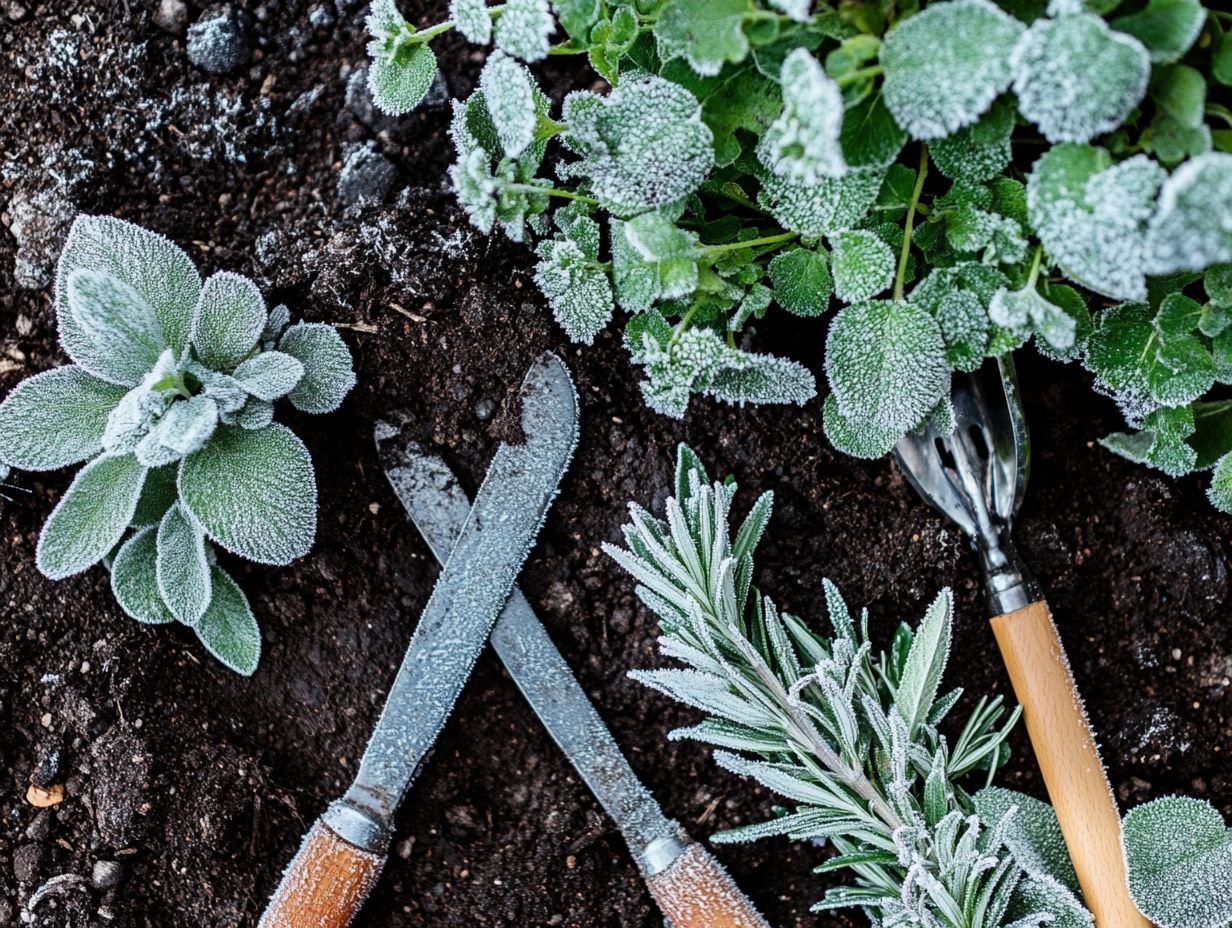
[0,216,355,674]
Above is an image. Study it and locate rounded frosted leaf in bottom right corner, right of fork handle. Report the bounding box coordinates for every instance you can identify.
[1122,796,1232,928]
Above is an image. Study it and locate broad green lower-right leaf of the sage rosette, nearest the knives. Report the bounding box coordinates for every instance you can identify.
[179,424,317,564]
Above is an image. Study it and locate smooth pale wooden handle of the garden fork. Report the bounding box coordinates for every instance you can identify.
[992,600,1151,928]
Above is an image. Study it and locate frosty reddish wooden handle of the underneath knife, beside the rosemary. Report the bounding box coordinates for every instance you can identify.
[646,844,770,928]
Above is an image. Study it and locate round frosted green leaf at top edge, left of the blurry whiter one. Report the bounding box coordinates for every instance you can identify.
[881,0,1025,139]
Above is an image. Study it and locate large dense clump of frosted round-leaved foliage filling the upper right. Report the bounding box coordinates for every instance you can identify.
[370,0,1232,510]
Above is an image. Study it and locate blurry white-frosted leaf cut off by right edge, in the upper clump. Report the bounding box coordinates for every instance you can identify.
[1146,152,1232,274]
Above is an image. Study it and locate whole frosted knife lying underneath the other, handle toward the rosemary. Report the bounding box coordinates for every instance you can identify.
[377,425,766,928]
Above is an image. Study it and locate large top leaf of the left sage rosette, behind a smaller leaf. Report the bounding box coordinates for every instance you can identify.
[55,216,201,369]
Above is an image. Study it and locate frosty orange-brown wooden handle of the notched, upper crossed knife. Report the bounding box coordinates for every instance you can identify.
[257,820,384,928]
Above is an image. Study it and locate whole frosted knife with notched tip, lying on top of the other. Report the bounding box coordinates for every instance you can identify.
[260,354,578,928]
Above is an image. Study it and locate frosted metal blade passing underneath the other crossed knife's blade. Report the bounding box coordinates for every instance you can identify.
[382,436,676,857]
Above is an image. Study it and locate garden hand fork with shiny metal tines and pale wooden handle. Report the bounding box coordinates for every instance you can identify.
[894,355,1149,928]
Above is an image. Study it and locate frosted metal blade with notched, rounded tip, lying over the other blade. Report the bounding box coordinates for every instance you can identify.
[342,354,578,824]
